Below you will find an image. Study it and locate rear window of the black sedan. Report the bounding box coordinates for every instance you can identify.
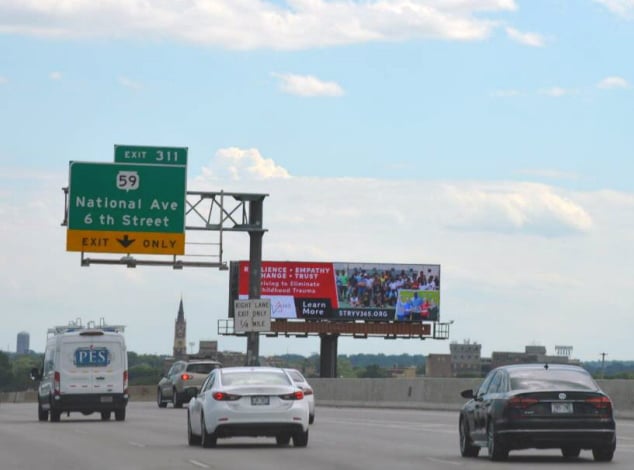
[509,369,598,390]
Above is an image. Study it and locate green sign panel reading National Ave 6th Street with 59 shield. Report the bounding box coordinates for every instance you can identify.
[68,162,187,234]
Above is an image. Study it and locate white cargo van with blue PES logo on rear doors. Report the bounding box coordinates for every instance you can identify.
[31,320,128,422]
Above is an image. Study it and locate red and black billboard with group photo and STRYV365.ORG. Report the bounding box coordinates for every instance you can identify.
[229,261,440,322]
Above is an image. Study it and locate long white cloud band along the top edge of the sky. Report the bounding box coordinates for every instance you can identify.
[0,0,517,50]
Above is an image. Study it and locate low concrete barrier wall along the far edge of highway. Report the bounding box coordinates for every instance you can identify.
[0,377,634,419]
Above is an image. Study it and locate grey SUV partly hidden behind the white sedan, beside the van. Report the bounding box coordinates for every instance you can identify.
[156,359,222,408]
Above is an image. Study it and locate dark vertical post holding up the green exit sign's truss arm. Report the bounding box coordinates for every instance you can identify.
[246,199,264,366]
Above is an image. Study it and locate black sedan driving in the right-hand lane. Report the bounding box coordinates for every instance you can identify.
[459,364,616,462]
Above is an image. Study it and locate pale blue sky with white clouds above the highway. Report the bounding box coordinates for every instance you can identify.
[0,0,634,361]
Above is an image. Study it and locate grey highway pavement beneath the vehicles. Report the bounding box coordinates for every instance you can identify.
[0,402,634,470]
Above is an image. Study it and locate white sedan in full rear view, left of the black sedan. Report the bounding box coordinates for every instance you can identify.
[187,367,309,447]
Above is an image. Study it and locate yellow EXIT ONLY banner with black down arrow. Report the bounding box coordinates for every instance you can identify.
[66,230,185,255]
